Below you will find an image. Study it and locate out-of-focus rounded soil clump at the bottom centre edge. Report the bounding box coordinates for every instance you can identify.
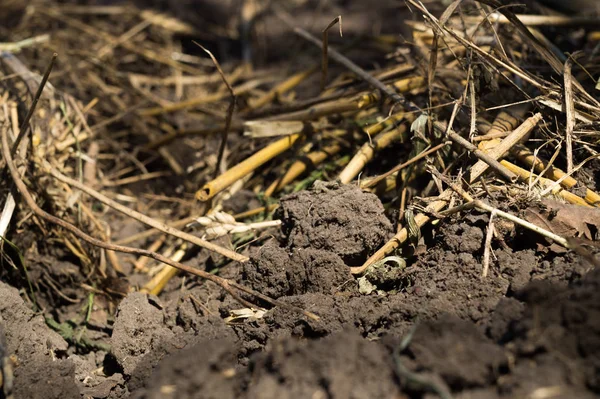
[247,331,399,399]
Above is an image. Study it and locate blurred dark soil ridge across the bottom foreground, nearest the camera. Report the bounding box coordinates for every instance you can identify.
[131,271,600,398]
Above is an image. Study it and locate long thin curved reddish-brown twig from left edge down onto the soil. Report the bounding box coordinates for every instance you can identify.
[2,128,319,320]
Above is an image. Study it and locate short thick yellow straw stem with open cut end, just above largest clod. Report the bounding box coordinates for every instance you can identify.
[196,133,301,201]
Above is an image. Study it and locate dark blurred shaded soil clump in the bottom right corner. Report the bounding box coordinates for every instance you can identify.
[504,270,600,397]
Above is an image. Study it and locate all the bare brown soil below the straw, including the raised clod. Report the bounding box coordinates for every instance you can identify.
[0,185,600,398]
